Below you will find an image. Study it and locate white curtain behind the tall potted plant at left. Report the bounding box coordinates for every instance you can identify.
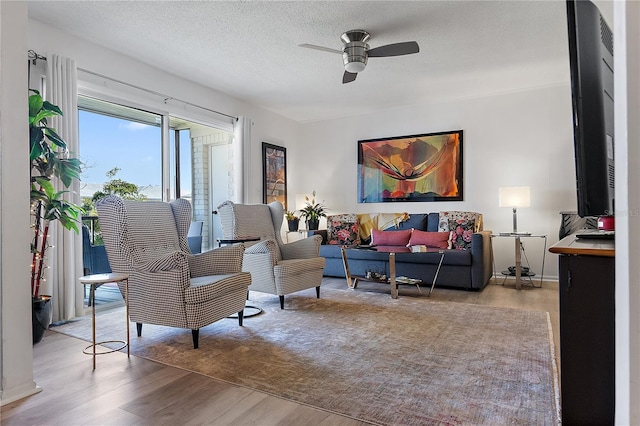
[45,54,84,321]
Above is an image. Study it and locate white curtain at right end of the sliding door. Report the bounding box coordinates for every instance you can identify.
[233,117,252,203]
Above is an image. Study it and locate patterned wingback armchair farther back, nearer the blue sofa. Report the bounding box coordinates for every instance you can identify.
[218,201,324,309]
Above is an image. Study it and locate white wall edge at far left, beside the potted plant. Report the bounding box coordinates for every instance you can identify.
[0,2,39,405]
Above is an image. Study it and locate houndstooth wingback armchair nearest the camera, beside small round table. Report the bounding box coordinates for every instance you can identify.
[96,195,251,349]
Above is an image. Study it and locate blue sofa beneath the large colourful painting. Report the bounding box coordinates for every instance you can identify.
[313,213,493,290]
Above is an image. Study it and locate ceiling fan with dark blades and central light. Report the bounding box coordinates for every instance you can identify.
[300,30,420,84]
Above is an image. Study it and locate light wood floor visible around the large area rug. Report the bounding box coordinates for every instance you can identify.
[0,278,559,426]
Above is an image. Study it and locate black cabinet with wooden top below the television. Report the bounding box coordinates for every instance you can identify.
[549,235,615,425]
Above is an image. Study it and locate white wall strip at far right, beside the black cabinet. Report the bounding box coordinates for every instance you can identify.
[613,2,640,425]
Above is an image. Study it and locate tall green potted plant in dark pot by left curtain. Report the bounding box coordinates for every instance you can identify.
[29,90,83,344]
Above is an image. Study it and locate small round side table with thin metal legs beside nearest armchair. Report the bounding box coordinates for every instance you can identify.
[79,273,131,370]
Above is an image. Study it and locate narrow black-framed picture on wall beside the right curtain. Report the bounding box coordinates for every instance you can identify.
[262,142,287,210]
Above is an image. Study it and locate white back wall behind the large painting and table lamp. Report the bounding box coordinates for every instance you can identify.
[296,85,576,278]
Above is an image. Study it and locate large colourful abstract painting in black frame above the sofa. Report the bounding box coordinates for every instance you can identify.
[358,130,463,203]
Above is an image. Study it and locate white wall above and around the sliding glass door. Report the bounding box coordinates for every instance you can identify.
[29,20,299,207]
